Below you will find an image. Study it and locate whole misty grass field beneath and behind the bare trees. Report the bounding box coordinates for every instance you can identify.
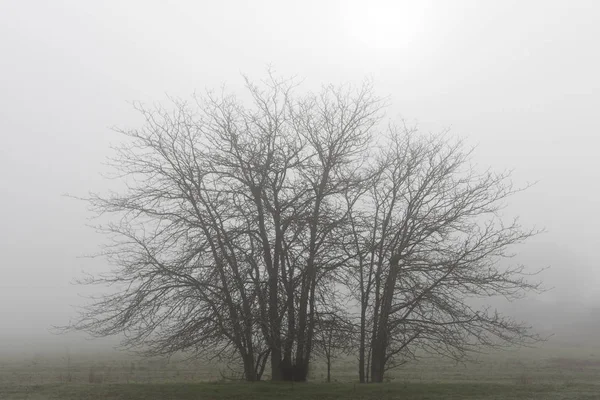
[0,346,600,400]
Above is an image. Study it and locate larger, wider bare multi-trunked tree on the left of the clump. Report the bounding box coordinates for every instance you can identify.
[68,75,380,381]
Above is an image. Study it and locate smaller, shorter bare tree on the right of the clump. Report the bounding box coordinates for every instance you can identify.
[342,126,539,382]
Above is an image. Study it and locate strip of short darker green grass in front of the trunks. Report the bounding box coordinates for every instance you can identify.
[0,382,600,400]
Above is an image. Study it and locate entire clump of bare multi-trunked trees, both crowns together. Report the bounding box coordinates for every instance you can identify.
[67,74,537,382]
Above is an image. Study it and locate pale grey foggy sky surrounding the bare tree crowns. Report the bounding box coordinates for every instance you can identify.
[0,0,600,356]
